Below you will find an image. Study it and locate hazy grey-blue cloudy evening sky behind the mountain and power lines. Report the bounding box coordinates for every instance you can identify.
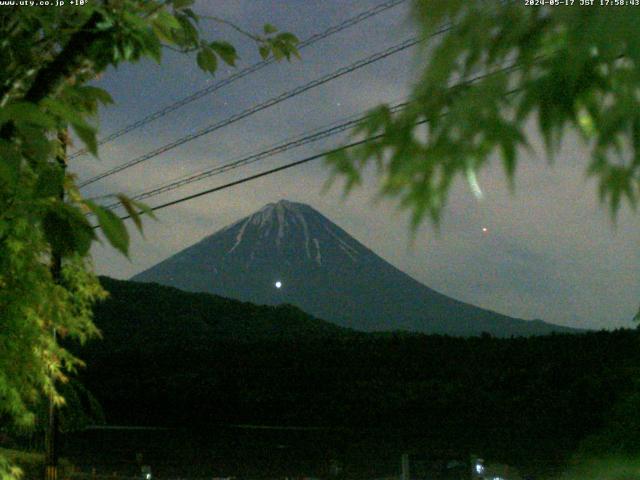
[76,0,640,328]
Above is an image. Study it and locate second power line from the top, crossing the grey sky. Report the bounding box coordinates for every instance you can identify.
[79,25,453,188]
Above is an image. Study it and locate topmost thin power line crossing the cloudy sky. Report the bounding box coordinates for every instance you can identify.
[69,0,406,159]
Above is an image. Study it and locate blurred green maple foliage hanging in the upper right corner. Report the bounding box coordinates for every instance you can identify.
[329,0,640,224]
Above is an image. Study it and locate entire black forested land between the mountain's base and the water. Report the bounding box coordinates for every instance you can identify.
[79,278,640,474]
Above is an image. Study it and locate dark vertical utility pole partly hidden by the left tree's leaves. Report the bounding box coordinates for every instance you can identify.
[44,129,68,480]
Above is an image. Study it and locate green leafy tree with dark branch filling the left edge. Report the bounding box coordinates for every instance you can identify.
[0,0,297,479]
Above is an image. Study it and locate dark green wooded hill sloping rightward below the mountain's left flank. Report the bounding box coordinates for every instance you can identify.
[92,277,352,351]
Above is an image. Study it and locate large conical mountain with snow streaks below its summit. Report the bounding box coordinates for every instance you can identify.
[131,200,576,337]
